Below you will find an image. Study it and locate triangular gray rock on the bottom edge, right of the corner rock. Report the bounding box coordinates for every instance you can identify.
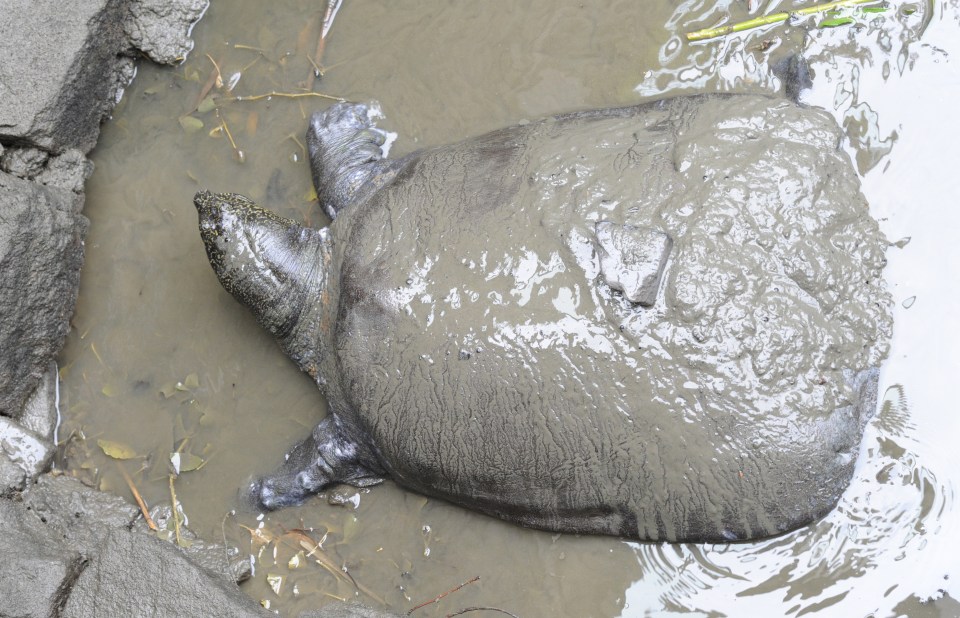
[61,529,272,618]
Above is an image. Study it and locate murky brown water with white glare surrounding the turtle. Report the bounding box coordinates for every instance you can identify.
[60,0,960,616]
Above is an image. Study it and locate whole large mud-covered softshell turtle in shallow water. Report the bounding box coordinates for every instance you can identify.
[195,95,891,541]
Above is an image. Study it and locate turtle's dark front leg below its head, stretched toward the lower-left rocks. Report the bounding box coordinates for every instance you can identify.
[250,414,385,510]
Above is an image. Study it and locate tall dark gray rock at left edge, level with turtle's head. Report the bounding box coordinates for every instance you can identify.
[0,172,88,416]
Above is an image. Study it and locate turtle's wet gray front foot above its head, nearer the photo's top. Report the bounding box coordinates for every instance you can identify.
[307,103,394,219]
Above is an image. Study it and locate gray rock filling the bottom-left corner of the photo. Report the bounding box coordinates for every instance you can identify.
[0,500,85,618]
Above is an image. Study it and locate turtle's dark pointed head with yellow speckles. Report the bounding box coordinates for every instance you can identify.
[193,191,328,344]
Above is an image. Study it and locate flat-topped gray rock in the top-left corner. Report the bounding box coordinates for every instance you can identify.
[0,0,133,152]
